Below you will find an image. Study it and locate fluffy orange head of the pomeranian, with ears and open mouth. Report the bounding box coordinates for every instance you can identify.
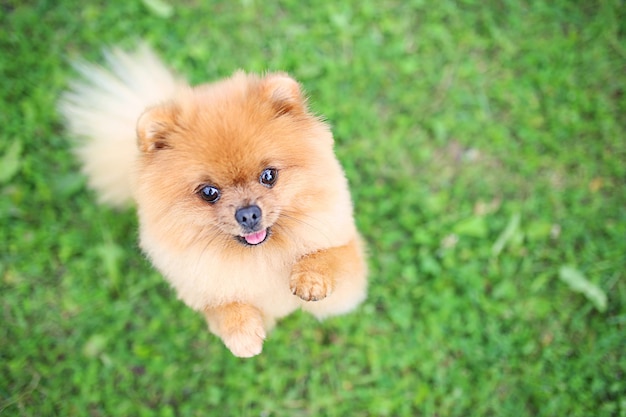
[132,73,341,252]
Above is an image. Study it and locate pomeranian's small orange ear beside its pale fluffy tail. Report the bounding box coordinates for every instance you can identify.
[137,104,177,152]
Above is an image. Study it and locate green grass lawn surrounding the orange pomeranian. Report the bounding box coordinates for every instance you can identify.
[0,0,626,417]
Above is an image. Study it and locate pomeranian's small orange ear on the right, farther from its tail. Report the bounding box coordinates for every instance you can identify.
[263,73,307,116]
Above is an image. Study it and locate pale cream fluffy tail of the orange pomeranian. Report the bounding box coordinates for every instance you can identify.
[58,45,184,207]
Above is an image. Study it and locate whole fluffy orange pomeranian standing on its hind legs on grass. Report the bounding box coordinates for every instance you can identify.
[59,46,367,357]
